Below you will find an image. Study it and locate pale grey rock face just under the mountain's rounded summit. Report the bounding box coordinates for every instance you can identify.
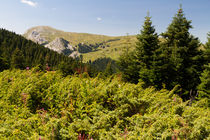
[27,31,48,45]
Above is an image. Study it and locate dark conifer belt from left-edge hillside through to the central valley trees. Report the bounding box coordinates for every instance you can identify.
[0,29,114,77]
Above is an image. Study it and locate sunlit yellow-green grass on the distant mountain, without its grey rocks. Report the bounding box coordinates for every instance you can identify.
[24,26,136,61]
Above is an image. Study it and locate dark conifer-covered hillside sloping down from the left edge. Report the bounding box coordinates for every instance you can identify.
[0,29,74,70]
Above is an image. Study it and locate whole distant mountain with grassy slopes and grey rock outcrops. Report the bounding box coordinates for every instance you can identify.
[23,26,136,61]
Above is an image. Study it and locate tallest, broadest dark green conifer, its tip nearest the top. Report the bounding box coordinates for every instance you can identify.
[162,7,202,94]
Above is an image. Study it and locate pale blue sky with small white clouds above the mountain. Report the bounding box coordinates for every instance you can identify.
[0,0,210,43]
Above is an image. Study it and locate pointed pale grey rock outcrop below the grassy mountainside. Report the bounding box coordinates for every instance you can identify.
[45,38,76,55]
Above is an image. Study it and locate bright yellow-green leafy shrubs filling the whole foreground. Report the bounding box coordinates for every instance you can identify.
[0,70,210,140]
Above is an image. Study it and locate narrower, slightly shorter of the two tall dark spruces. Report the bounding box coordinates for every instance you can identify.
[135,13,162,88]
